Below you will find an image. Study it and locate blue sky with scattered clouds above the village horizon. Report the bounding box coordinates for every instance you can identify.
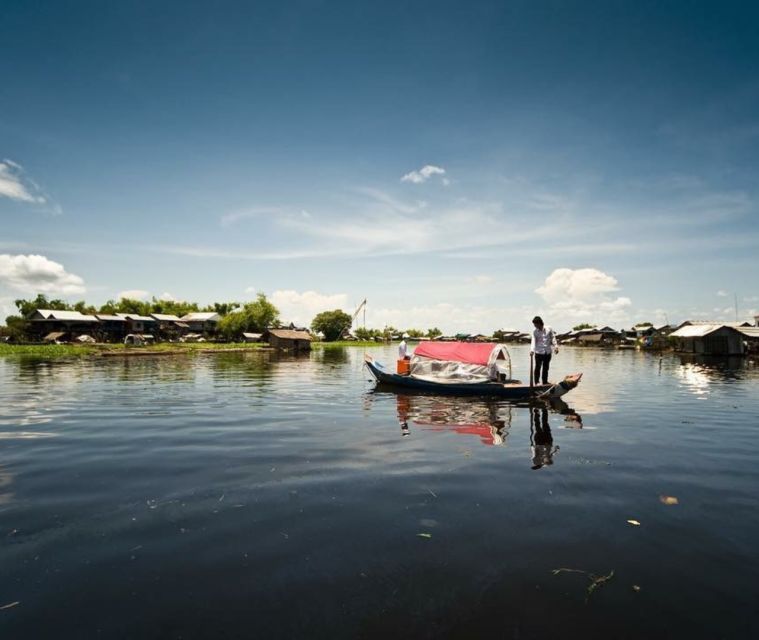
[0,0,759,333]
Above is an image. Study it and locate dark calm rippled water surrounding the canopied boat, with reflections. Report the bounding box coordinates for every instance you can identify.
[0,347,759,639]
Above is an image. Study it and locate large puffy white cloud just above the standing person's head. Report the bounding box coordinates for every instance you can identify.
[535,268,632,324]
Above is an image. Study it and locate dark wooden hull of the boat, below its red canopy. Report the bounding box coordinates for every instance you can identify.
[364,354,582,400]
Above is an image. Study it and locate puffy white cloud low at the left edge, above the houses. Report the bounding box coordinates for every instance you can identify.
[0,254,86,295]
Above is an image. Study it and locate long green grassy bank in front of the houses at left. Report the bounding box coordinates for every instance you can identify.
[0,342,267,358]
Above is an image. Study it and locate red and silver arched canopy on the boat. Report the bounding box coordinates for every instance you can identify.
[410,342,511,383]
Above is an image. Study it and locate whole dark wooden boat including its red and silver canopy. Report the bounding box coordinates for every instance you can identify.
[364,342,582,400]
